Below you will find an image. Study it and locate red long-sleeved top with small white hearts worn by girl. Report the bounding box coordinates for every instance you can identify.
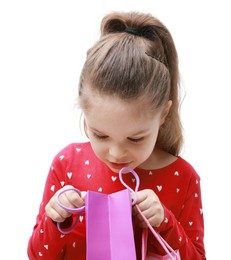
[28,143,206,260]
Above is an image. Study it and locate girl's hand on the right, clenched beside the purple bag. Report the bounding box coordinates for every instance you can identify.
[133,189,164,227]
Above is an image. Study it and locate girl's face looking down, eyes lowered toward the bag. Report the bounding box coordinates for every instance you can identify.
[84,91,170,172]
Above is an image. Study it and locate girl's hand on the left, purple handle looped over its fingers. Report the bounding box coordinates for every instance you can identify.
[45,185,86,222]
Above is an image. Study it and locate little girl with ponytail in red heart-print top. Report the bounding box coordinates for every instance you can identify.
[28,12,206,260]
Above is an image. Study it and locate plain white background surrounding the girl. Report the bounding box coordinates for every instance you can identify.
[0,0,231,260]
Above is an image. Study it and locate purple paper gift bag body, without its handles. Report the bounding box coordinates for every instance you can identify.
[85,190,136,260]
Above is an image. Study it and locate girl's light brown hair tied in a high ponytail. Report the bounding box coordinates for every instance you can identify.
[79,12,183,155]
